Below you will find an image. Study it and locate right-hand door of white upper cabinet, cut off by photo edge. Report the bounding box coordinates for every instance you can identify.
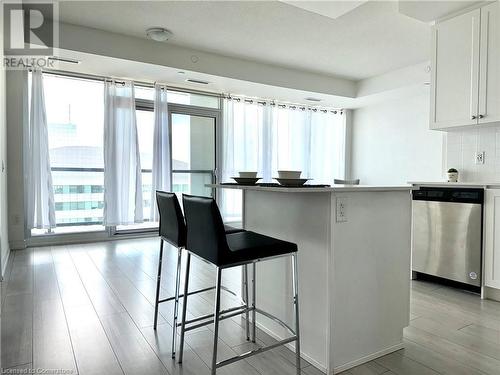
[479,2,500,124]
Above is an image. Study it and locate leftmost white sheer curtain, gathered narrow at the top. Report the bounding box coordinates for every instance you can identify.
[26,70,56,229]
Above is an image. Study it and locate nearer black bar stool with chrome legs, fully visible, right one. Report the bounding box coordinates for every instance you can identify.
[179,194,300,375]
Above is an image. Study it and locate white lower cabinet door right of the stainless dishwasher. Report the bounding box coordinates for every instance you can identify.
[484,189,500,289]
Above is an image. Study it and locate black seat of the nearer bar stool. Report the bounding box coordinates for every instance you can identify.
[224,231,297,268]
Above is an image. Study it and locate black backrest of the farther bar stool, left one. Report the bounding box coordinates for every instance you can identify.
[156,191,186,247]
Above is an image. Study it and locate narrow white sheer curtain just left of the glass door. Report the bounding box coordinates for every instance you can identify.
[150,84,172,221]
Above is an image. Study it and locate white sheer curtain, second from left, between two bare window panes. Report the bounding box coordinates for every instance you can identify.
[104,81,143,226]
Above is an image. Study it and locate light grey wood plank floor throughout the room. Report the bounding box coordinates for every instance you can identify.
[1,238,500,375]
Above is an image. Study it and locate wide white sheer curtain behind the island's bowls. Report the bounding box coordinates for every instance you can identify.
[222,98,346,221]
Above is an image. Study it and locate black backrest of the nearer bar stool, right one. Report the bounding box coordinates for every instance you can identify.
[182,194,230,265]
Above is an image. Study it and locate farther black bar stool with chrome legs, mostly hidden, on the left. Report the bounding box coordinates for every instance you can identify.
[153,191,248,358]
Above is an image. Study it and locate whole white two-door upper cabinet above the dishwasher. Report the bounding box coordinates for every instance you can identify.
[430,2,500,129]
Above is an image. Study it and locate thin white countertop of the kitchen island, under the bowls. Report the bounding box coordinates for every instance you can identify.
[205,184,414,193]
